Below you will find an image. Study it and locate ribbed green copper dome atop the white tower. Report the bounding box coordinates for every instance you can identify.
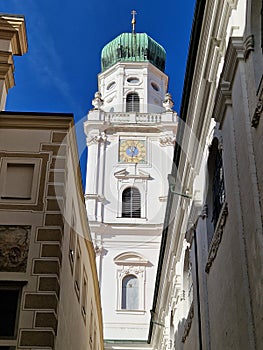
[101,33,166,72]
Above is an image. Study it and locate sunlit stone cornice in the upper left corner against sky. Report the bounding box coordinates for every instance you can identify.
[0,14,28,56]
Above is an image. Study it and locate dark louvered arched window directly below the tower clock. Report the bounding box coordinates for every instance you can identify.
[122,187,141,218]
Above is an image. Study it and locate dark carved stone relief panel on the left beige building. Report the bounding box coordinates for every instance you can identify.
[0,225,31,272]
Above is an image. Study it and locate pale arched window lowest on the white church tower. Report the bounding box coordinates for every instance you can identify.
[121,275,139,310]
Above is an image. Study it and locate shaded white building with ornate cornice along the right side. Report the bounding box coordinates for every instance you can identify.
[150,0,263,350]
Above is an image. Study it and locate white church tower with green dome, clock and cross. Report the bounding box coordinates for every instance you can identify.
[84,11,178,349]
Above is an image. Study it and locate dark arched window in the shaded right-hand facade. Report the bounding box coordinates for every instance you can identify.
[212,149,225,228]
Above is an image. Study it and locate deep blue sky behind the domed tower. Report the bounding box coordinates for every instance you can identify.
[0,0,195,186]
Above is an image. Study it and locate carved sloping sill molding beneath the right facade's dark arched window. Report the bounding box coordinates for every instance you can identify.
[205,202,228,273]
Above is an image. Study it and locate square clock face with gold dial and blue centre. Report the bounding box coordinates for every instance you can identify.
[119,139,146,163]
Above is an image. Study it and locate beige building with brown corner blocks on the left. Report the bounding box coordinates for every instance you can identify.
[0,112,103,350]
